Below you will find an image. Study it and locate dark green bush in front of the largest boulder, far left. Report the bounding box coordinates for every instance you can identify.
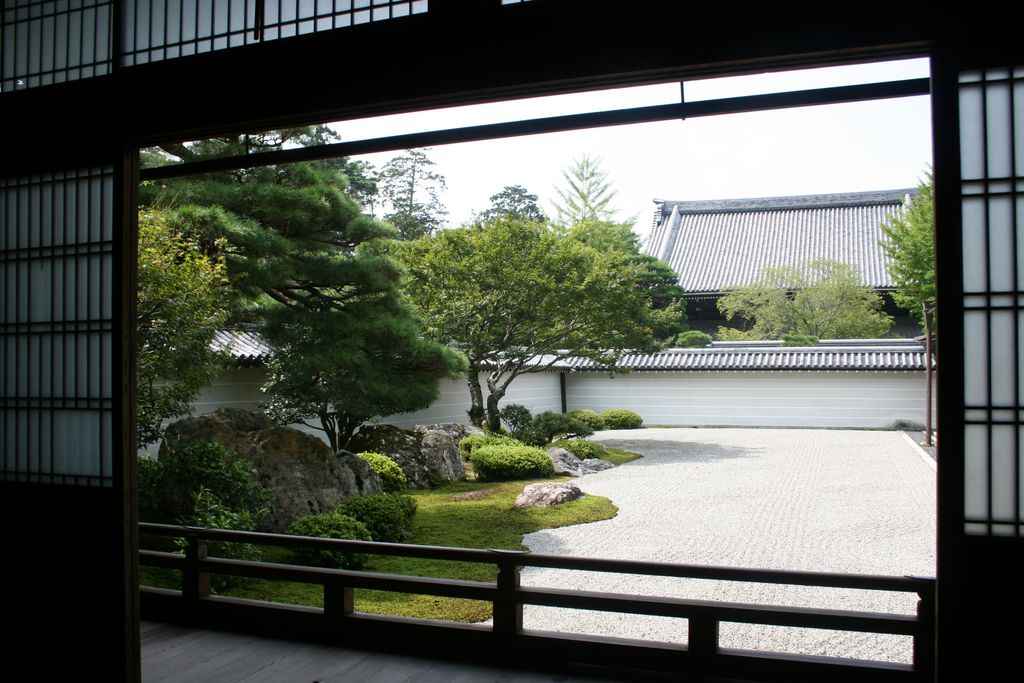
[139,441,273,524]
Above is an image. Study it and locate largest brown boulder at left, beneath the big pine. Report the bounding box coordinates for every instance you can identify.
[160,408,382,531]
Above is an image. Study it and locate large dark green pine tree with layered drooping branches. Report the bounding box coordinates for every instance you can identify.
[141,133,464,447]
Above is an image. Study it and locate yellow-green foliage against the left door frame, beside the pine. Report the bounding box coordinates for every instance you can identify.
[135,209,226,446]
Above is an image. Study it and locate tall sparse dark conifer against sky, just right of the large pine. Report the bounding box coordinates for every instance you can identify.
[377,150,447,240]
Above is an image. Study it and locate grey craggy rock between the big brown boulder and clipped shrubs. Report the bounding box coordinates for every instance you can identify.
[349,425,466,488]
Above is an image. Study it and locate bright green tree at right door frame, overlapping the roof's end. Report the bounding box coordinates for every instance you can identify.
[881,172,935,325]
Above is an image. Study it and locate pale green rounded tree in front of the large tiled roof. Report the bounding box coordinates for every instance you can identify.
[718,259,892,340]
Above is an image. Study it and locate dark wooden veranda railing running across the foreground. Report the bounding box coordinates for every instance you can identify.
[139,523,935,682]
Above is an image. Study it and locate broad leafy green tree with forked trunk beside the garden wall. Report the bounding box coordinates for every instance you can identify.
[400,217,675,431]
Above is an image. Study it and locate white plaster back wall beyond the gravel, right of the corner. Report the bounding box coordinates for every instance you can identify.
[566,372,925,428]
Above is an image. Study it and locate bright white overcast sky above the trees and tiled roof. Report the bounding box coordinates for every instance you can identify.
[335,59,932,242]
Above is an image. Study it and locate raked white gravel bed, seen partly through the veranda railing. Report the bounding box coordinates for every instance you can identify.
[522,428,936,661]
